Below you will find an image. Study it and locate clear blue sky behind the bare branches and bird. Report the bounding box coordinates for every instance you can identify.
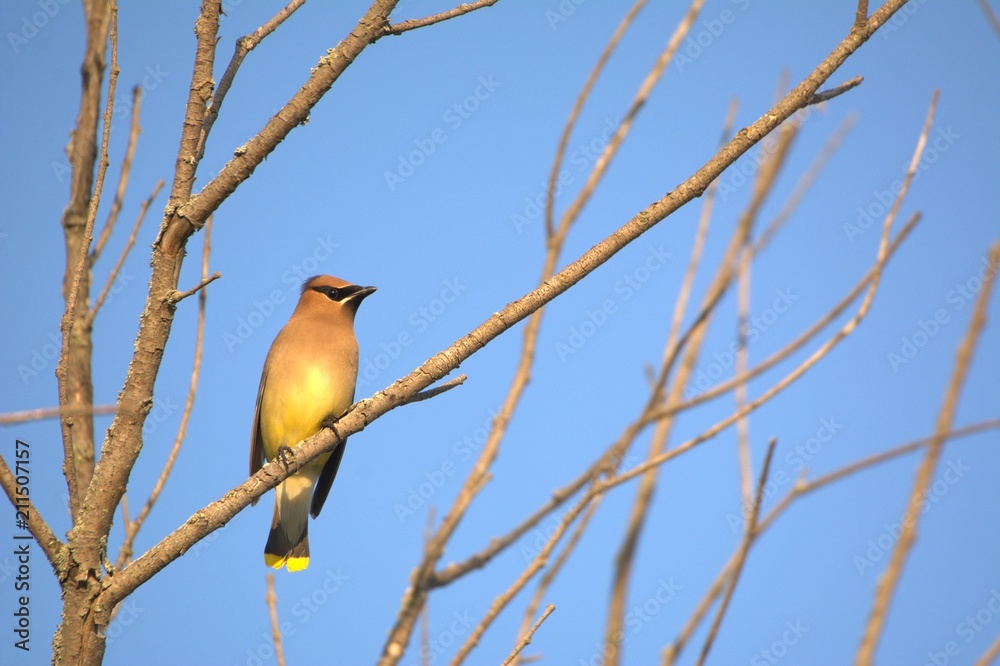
[0,0,1000,665]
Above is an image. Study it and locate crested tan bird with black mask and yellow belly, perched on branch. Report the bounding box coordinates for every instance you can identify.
[250,275,375,571]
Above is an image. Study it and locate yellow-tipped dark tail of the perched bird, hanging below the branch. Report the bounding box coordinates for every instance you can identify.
[264,474,315,571]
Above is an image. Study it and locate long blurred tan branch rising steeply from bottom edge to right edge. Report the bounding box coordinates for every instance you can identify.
[855,241,1000,666]
